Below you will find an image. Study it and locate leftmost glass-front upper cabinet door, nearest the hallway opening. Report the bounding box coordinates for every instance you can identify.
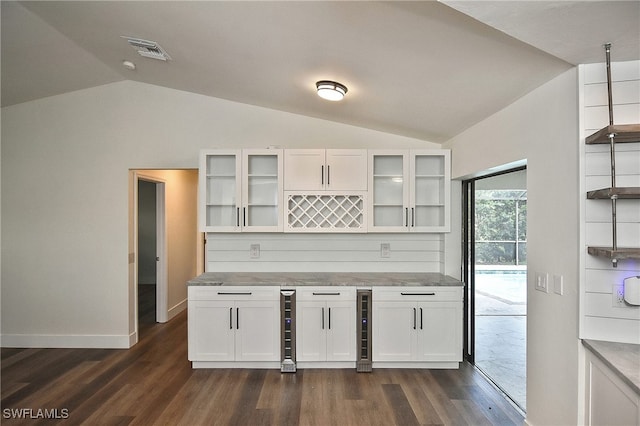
[199,150,242,232]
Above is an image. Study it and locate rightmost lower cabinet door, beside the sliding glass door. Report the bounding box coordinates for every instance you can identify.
[418,302,462,361]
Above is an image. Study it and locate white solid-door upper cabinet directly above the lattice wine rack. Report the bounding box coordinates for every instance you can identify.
[284,149,367,192]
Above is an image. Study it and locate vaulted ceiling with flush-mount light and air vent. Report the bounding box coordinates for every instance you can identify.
[1,1,640,142]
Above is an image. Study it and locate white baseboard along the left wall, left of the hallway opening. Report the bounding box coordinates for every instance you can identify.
[0,333,136,349]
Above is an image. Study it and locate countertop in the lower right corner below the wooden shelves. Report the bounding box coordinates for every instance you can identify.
[582,340,640,395]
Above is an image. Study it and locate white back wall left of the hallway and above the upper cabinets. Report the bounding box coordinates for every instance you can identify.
[1,81,439,347]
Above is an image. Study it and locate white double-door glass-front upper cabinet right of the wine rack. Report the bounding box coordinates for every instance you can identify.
[368,149,451,232]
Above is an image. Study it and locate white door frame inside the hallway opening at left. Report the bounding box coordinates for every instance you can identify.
[132,170,169,340]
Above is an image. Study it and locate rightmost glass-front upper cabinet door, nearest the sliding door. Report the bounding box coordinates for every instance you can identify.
[409,150,451,232]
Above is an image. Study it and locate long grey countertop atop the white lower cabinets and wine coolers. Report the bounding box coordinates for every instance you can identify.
[187,272,464,287]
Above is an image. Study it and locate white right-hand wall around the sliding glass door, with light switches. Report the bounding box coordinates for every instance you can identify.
[443,69,581,425]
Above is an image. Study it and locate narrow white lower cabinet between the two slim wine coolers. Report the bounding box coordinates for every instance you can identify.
[296,287,356,367]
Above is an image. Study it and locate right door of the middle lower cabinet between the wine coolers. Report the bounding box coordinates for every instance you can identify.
[325,301,356,361]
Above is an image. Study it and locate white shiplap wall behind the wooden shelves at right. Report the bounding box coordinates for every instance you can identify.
[580,61,640,344]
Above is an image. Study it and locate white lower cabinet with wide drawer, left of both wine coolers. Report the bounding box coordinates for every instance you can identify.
[188,286,280,368]
